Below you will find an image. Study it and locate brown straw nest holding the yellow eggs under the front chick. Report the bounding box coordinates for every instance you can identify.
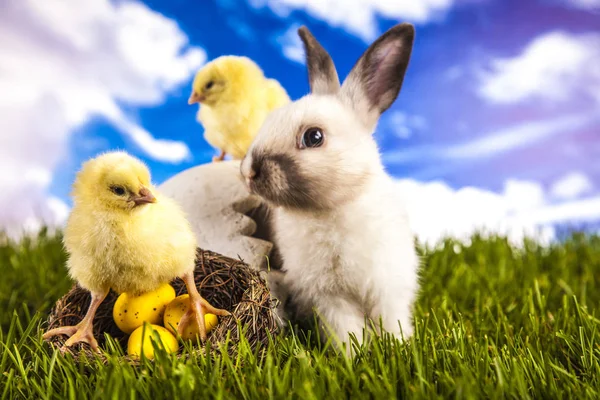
[47,249,279,362]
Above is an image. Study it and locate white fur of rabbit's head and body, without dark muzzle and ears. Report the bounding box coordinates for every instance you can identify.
[241,95,419,342]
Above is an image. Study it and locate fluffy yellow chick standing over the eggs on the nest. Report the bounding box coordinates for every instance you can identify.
[44,152,229,351]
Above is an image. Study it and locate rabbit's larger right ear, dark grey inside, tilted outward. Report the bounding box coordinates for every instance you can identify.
[340,23,415,129]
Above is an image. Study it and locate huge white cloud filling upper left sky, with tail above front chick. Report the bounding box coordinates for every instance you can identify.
[0,0,205,236]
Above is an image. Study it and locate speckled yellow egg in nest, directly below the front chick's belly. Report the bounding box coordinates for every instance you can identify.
[113,283,175,333]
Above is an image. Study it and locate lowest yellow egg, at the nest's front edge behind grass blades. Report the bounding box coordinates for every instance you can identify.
[127,322,179,359]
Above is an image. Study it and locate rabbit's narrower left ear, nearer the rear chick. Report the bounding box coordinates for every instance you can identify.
[298,26,340,94]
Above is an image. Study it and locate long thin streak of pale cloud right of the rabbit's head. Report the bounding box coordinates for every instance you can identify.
[383,112,600,164]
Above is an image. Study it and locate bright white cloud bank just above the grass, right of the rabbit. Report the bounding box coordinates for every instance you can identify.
[398,179,600,245]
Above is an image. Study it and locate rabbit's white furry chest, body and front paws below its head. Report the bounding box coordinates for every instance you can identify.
[274,173,418,348]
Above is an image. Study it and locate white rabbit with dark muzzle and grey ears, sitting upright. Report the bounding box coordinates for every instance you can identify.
[240,23,419,354]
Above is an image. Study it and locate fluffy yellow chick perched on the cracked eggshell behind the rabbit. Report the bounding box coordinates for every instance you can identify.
[188,56,290,161]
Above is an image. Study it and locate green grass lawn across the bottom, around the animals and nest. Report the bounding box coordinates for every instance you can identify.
[0,230,600,399]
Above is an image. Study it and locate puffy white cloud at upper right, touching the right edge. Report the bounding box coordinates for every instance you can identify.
[479,31,600,103]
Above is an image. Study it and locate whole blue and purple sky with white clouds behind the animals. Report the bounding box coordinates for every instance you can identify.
[0,0,600,241]
